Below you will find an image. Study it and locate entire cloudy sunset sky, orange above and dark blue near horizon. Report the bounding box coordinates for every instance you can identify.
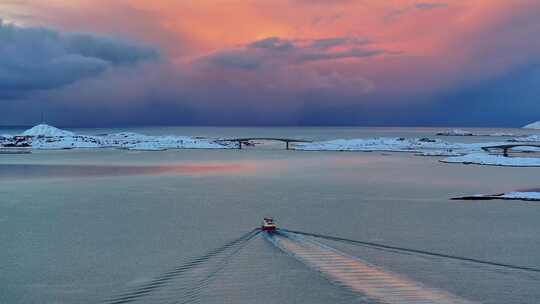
[0,0,540,127]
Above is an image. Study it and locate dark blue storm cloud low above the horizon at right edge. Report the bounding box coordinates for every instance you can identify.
[422,60,540,127]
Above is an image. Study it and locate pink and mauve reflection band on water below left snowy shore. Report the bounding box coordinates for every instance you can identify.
[0,162,257,179]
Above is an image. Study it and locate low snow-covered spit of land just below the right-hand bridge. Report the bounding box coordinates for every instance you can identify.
[441,152,540,167]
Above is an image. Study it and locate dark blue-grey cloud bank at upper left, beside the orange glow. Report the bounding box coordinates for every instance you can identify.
[0,22,158,99]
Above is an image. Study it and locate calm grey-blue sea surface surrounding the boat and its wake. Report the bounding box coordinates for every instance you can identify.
[0,128,540,303]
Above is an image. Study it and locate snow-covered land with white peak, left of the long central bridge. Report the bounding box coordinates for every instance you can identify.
[0,124,234,151]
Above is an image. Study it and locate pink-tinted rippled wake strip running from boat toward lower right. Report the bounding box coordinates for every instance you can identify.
[265,231,475,304]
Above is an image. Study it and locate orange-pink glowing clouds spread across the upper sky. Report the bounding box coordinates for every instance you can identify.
[4,0,540,126]
